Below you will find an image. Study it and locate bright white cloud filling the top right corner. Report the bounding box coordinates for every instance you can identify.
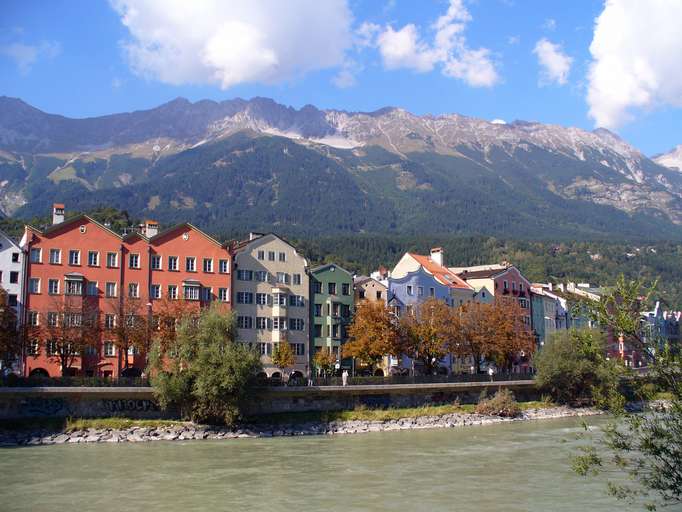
[587,0,682,128]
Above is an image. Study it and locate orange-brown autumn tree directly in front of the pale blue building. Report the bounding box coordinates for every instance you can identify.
[398,298,455,375]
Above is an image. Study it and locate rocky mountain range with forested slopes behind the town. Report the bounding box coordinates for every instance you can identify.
[0,97,682,240]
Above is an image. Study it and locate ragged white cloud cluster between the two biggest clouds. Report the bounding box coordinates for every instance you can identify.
[376,0,499,87]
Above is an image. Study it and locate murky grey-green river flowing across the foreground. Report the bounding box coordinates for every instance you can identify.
[0,418,624,512]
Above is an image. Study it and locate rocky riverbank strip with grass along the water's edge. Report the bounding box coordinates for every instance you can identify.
[0,406,602,447]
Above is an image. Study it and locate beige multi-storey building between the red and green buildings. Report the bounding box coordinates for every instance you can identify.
[232,233,310,377]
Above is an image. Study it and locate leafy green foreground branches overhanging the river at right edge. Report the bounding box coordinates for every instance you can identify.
[573,278,682,510]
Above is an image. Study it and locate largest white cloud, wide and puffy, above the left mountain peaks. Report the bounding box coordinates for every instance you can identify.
[111,0,352,89]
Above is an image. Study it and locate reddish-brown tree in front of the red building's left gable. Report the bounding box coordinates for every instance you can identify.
[37,295,101,376]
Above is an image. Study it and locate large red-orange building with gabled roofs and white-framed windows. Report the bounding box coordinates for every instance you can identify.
[22,204,232,377]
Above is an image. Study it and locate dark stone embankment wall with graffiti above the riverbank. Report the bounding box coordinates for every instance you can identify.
[0,381,538,419]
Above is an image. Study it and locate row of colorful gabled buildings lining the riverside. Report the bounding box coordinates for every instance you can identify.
[0,204,660,378]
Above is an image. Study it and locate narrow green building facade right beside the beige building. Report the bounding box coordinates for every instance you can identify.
[310,263,355,362]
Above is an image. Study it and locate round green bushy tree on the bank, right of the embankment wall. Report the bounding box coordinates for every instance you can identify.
[533,329,624,409]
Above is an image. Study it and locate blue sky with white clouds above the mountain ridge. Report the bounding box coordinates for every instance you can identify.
[0,0,682,155]
